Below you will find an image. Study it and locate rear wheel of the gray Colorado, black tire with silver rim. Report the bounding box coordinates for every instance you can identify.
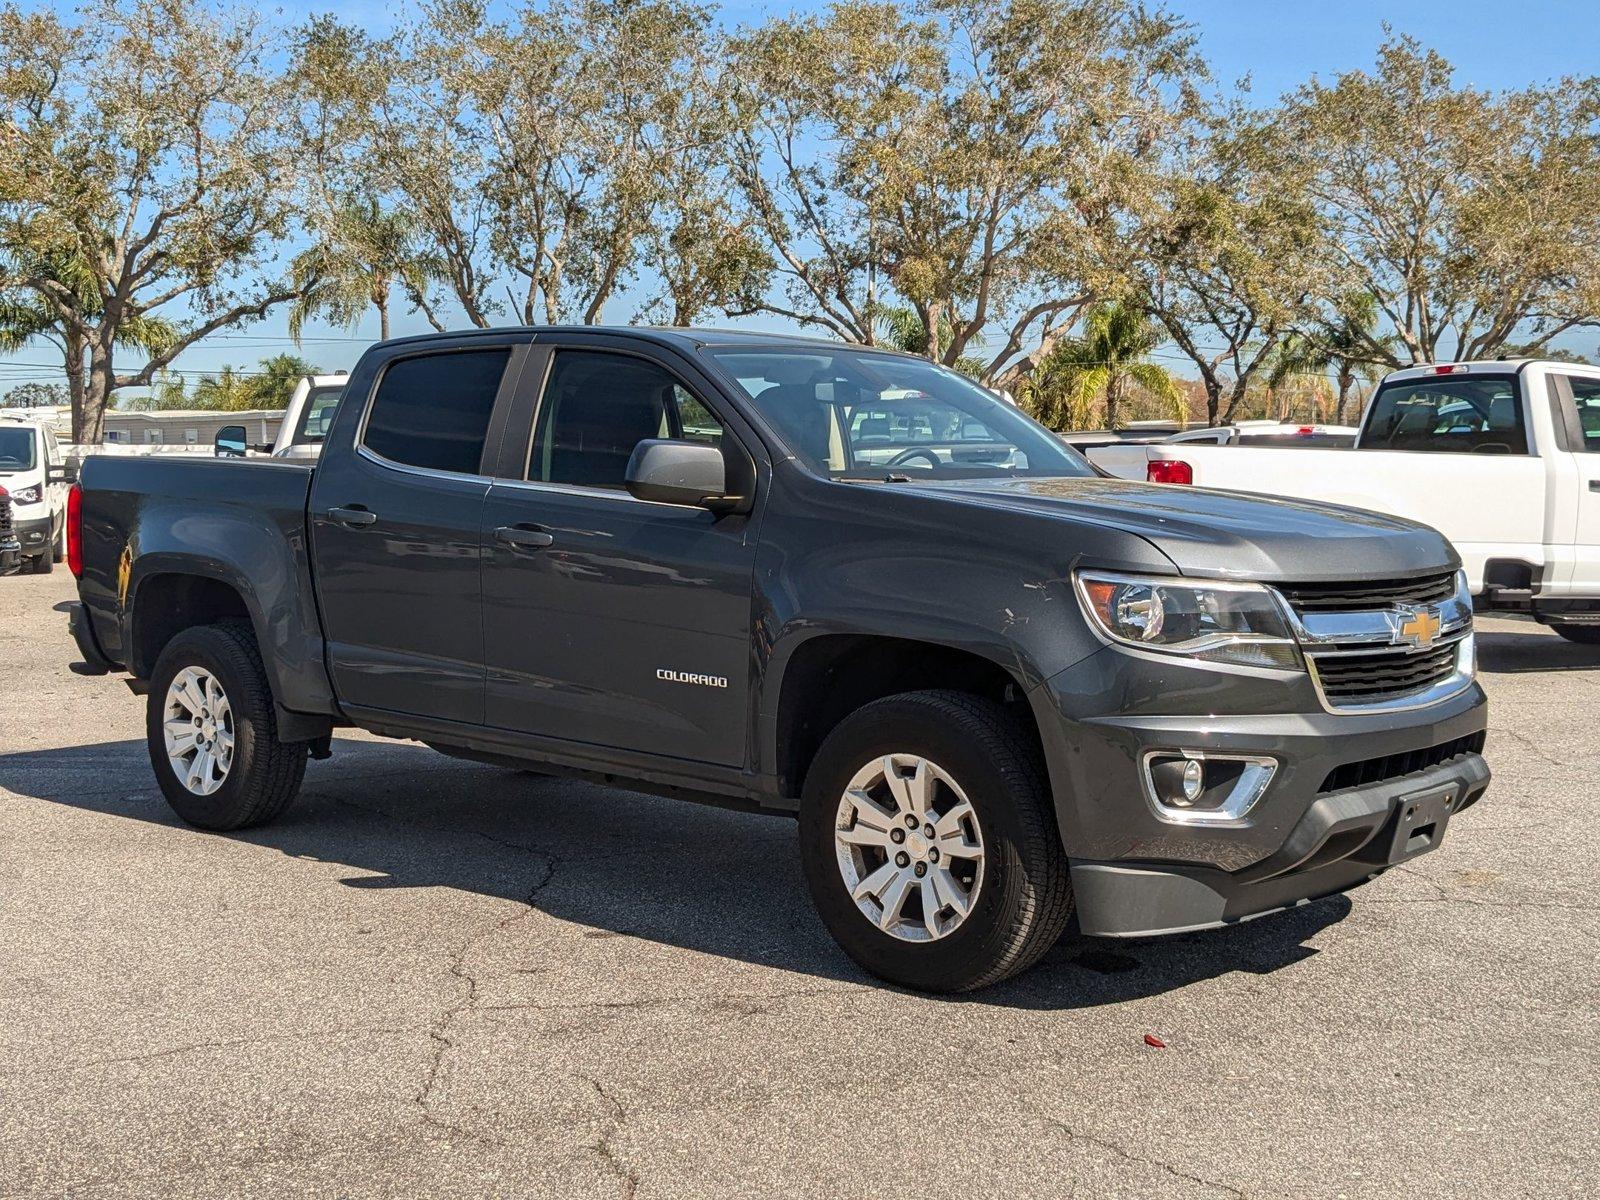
[146,621,309,832]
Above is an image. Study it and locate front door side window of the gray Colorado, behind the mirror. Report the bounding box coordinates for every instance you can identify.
[528,350,722,488]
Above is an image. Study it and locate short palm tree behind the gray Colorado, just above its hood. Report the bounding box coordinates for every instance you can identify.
[1022,301,1189,429]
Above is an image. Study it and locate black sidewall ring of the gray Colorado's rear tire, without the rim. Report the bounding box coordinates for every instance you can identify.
[146,627,264,829]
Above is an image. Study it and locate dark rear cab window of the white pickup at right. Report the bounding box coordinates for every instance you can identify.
[1362,374,1528,454]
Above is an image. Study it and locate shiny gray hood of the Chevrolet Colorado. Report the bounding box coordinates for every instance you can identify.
[894,478,1461,582]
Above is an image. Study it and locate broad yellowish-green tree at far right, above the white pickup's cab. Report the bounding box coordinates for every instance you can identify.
[1261,35,1600,366]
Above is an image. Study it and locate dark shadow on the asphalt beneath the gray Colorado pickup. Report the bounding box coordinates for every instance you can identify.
[0,739,1350,1010]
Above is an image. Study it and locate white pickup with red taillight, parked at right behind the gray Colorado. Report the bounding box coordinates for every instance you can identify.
[1086,360,1600,645]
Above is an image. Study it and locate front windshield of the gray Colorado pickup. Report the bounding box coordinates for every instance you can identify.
[714,349,1094,480]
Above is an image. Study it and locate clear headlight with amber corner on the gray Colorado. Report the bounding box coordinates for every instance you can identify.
[1077,571,1304,670]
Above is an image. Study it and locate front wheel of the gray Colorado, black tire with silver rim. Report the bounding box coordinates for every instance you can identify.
[800,691,1072,992]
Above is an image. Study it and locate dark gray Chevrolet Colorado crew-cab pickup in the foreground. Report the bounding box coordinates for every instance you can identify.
[59,328,1490,990]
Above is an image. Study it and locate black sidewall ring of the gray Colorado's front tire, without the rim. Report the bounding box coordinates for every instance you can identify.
[800,701,1027,990]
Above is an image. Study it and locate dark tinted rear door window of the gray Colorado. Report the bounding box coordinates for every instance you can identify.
[362,350,510,475]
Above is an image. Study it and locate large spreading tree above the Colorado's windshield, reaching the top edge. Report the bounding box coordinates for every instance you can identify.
[730,0,1202,386]
